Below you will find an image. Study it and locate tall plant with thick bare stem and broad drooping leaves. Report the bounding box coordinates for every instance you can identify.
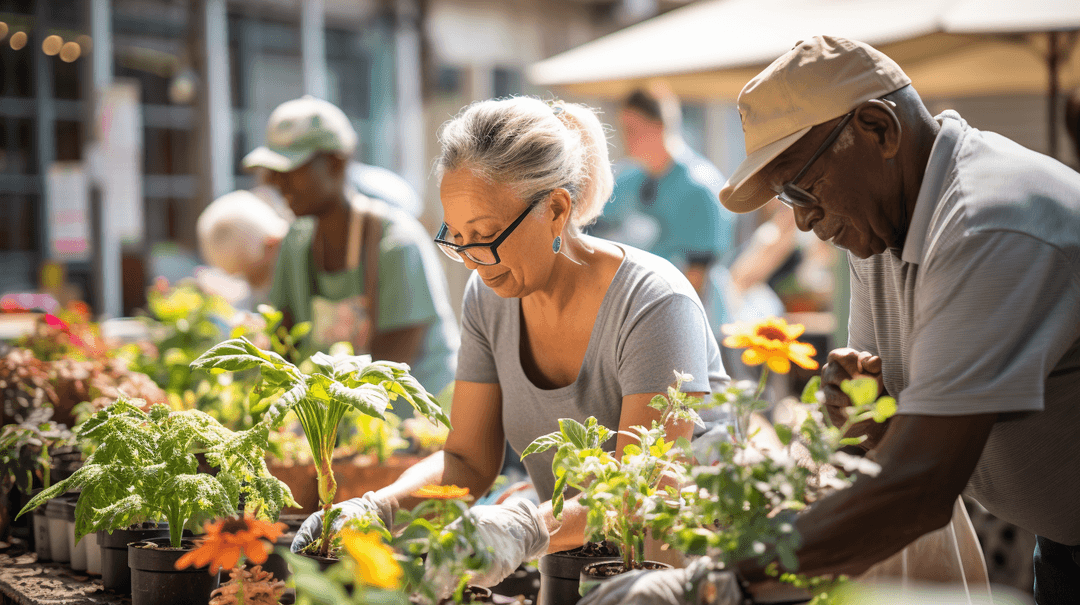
[191,337,449,556]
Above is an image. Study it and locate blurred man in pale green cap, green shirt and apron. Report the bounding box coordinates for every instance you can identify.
[243,96,459,399]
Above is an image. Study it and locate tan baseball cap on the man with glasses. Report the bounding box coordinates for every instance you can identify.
[720,36,912,213]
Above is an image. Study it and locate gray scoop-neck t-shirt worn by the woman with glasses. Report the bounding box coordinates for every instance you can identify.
[457,245,728,499]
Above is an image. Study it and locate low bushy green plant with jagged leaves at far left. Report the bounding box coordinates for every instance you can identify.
[19,396,295,548]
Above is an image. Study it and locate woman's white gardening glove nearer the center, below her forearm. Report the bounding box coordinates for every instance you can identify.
[424,499,549,595]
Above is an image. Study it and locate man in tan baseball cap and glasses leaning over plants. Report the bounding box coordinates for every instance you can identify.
[582,36,1080,605]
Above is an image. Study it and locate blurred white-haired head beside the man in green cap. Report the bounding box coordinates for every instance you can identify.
[195,189,289,310]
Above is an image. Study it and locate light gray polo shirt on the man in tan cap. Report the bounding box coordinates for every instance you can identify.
[848,111,1080,545]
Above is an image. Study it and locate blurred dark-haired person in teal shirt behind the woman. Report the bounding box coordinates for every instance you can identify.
[594,86,734,333]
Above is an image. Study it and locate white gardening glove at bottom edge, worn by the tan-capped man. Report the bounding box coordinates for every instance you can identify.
[578,557,743,605]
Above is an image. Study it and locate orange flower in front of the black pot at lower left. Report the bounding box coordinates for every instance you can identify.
[176,515,285,574]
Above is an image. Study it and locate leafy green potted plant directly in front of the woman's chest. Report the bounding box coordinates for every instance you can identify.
[522,372,706,570]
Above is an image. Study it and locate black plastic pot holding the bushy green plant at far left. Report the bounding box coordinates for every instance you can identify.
[127,537,220,605]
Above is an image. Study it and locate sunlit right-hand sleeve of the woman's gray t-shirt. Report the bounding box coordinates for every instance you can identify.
[617,294,712,396]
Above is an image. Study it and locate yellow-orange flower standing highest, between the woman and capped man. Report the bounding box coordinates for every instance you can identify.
[723,318,818,374]
